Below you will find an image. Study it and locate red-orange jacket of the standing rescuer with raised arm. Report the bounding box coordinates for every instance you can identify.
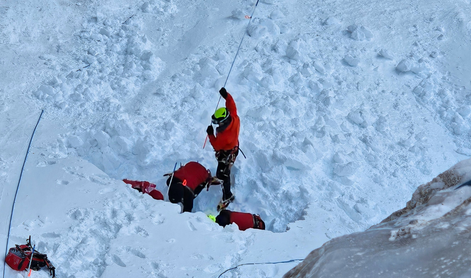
[209,93,240,151]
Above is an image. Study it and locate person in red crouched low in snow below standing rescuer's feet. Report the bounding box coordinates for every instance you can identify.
[216,210,265,231]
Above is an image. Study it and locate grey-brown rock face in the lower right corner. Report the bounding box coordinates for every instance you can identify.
[283,159,471,278]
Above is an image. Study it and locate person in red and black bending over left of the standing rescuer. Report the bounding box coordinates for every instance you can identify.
[164,161,220,212]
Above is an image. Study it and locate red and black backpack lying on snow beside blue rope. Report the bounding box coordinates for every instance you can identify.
[5,236,56,278]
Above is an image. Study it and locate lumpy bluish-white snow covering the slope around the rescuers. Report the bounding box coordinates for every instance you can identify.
[0,0,471,278]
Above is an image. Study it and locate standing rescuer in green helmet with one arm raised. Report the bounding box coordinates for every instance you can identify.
[206,87,240,210]
